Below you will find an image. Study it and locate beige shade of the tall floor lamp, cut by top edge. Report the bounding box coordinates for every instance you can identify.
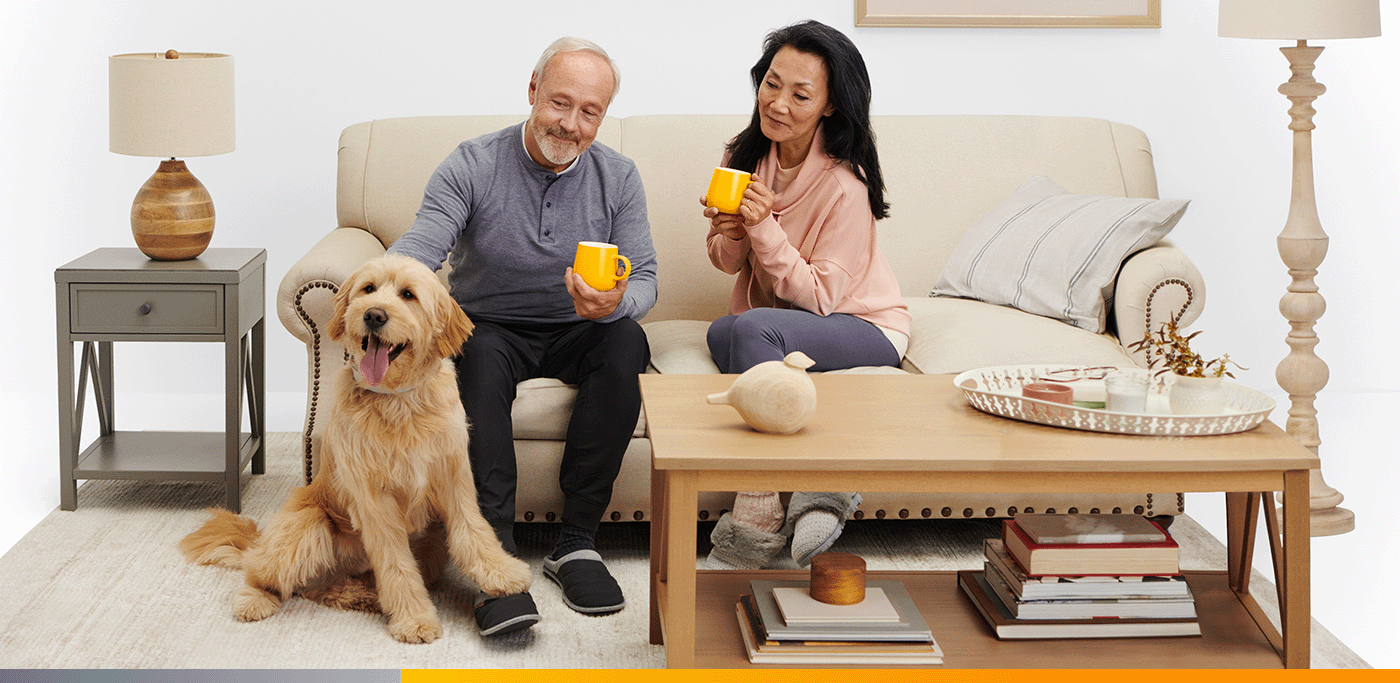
[1219,0,1380,41]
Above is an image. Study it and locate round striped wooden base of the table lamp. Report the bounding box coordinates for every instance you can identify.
[132,160,214,260]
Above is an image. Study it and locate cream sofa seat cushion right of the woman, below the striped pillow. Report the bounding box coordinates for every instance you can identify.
[904,297,1134,374]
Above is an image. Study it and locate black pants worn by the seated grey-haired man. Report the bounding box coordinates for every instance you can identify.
[455,318,651,532]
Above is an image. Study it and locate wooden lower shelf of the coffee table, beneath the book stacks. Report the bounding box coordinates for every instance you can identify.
[657,570,1282,669]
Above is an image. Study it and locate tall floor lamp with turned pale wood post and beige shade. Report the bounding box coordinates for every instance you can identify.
[1219,0,1380,536]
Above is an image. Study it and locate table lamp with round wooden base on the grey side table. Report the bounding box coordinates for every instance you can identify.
[108,50,234,260]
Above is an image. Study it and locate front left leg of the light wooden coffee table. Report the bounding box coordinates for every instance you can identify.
[665,470,699,669]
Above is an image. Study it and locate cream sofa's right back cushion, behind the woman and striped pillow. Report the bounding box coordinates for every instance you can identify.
[622,115,1156,321]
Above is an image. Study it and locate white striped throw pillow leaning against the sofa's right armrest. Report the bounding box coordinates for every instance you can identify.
[930,175,1190,332]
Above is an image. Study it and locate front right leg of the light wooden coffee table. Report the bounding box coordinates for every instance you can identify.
[1270,470,1312,669]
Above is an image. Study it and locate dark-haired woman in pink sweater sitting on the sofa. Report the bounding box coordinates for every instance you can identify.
[701,21,910,568]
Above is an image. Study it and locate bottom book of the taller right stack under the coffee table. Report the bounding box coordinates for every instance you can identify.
[958,570,1201,640]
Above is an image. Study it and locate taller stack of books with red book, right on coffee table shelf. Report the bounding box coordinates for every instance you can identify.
[958,515,1201,638]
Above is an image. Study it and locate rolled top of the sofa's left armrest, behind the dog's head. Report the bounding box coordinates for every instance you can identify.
[277,227,385,344]
